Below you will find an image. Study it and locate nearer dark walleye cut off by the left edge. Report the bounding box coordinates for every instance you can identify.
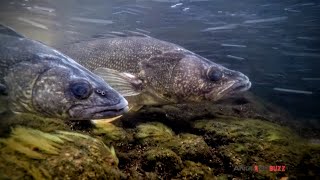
[0,25,128,120]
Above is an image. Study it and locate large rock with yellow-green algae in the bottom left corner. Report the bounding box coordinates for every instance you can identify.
[0,127,123,179]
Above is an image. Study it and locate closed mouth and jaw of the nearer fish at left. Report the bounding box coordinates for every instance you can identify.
[69,99,129,120]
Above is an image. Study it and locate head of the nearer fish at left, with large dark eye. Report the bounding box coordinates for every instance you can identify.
[32,54,128,120]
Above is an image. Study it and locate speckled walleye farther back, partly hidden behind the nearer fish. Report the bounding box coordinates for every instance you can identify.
[61,33,251,110]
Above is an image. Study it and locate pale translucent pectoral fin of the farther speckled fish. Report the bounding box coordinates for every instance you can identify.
[93,68,143,97]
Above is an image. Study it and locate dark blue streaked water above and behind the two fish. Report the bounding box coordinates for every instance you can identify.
[0,0,320,124]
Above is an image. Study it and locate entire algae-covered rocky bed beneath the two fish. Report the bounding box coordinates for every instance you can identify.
[0,94,320,179]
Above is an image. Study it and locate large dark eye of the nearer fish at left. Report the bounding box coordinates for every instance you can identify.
[70,81,92,99]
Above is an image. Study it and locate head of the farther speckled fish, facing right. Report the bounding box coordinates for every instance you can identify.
[172,54,251,102]
